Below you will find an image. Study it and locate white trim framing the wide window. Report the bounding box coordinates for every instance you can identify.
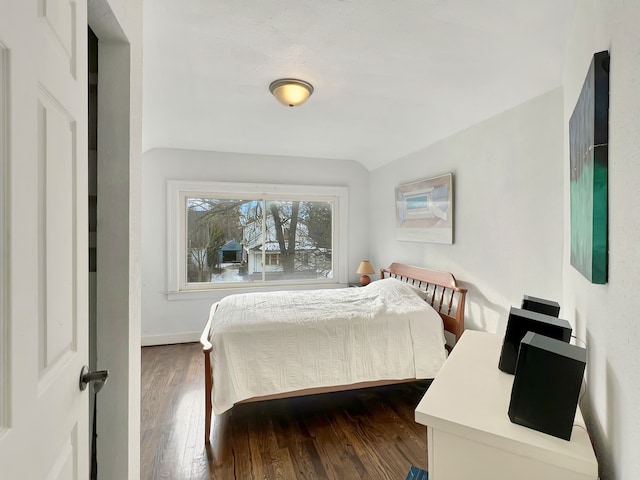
[167,180,349,297]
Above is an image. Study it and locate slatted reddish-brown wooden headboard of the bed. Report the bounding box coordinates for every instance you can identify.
[380,263,467,342]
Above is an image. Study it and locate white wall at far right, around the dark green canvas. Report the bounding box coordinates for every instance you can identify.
[562,0,640,480]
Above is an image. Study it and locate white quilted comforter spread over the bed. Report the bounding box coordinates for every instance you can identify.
[211,278,446,414]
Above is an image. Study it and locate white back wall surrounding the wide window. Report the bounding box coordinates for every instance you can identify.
[142,149,369,345]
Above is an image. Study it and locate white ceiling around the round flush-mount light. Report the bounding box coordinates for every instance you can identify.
[143,0,575,169]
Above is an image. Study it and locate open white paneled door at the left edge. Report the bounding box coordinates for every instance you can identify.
[0,0,90,480]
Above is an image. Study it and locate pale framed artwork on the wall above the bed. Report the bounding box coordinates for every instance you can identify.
[395,173,453,244]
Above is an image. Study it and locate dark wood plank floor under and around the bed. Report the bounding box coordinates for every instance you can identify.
[140,344,428,480]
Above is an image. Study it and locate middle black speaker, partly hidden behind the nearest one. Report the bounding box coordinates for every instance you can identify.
[498,307,571,373]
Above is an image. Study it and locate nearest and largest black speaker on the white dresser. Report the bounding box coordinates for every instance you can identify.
[509,332,587,440]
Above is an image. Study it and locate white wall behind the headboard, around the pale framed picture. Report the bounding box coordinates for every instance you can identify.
[369,89,565,332]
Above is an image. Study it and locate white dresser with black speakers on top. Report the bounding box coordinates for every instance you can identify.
[415,330,598,480]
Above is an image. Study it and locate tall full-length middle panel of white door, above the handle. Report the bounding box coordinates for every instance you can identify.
[37,92,77,379]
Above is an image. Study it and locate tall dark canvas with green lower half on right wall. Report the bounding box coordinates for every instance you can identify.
[569,51,609,284]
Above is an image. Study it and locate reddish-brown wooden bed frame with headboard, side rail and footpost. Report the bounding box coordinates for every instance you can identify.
[200,263,467,443]
